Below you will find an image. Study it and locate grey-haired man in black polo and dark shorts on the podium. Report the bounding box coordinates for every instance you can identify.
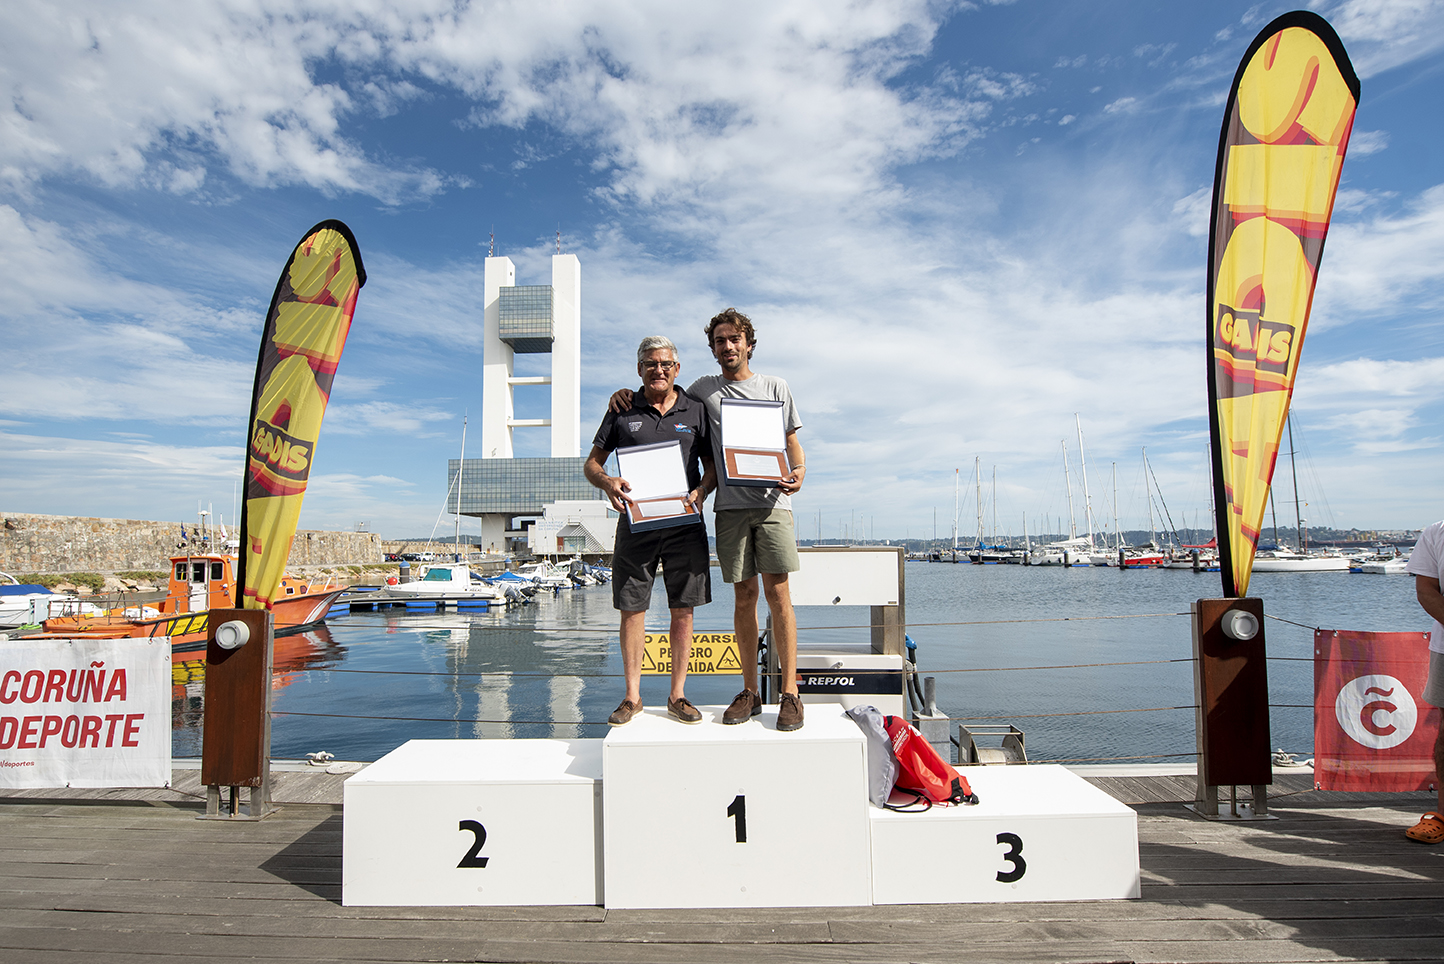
[583,335,716,726]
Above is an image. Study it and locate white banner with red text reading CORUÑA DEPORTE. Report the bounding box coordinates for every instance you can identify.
[0,636,170,789]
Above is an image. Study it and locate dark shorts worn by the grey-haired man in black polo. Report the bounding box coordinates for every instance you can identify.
[612,515,712,612]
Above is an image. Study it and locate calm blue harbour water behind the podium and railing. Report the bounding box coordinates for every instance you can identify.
[173,563,1430,763]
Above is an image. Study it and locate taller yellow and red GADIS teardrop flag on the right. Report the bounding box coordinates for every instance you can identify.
[1207,12,1359,596]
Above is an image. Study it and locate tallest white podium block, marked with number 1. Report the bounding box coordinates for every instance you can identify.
[602,703,872,908]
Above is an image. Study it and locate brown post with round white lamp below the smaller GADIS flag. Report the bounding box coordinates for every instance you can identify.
[198,609,279,823]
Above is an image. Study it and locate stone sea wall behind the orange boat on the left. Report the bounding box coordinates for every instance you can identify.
[0,512,381,574]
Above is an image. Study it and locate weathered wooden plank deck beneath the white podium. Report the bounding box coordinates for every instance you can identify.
[8,774,1444,964]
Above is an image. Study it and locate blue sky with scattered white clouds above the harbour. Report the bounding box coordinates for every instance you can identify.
[0,0,1444,538]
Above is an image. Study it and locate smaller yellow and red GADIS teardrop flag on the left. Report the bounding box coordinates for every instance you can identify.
[237,221,365,609]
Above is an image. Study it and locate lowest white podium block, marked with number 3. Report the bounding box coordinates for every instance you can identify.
[869,765,1139,903]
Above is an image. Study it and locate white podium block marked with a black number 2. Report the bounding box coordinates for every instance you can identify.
[341,740,602,906]
